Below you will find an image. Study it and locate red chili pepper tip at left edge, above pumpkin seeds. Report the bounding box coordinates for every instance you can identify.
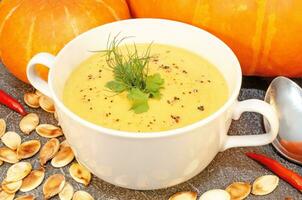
[0,90,27,116]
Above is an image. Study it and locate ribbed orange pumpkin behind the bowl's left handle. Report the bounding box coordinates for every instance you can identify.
[0,0,130,82]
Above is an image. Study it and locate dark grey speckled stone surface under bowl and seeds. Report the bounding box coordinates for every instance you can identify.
[0,63,302,200]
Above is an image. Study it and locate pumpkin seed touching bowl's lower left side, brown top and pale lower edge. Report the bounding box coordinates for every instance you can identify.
[51,146,74,168]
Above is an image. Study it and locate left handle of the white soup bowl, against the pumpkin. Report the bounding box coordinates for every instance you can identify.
[26,53,56,97]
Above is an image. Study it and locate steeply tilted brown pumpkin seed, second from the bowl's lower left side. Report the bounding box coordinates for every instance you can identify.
[40,138,60,166]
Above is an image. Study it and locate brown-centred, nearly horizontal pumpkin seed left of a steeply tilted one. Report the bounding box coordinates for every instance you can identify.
[17,140,41,159]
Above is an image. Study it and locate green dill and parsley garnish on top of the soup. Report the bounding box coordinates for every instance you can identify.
[105,37,164,114]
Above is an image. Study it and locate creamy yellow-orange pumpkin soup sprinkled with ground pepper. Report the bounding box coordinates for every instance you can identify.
[63,44,229,132]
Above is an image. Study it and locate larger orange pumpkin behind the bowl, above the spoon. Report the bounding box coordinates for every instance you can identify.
[128,0,302,77]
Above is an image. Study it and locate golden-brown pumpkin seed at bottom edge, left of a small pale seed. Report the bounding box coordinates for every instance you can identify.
[43,174,65,199]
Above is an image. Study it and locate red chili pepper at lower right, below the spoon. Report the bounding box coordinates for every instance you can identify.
[246,152,302,192]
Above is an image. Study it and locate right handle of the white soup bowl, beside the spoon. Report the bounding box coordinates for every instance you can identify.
[221,99,279,151]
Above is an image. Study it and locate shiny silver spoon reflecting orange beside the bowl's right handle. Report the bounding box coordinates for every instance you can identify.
[264,76,302,164]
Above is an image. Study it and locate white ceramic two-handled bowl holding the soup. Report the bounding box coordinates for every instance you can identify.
[27,19,279,190]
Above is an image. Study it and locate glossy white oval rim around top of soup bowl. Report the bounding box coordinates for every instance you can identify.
[48,18,242,139]
